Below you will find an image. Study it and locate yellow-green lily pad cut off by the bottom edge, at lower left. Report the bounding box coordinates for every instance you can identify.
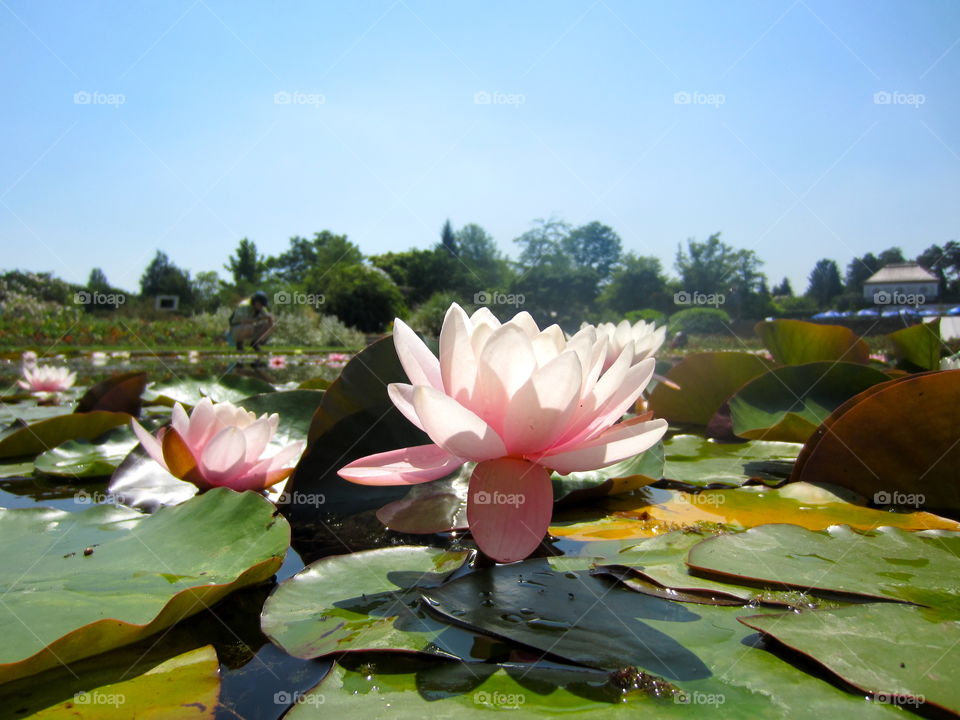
[31,645,220,720]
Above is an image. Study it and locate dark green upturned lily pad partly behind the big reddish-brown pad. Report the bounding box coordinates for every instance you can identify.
[730,362,890,442]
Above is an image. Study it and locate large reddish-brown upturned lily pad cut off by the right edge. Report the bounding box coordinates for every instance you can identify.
[792,371,960,512]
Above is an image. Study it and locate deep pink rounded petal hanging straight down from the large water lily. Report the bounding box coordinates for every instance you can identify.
[467,458,553,563]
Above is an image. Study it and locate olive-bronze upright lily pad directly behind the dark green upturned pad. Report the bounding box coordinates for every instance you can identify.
[753,319,870,365]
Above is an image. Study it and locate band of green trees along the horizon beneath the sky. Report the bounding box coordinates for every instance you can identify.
[50,218,960,332]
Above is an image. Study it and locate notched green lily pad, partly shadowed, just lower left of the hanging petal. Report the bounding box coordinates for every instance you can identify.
[261,546,506,660]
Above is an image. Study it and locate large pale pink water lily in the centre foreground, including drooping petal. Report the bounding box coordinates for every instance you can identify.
[339,304,667,562]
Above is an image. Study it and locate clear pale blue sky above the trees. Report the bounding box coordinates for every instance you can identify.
[0,0,960,289]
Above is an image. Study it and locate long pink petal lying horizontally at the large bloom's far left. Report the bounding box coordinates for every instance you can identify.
[337,445,464,485]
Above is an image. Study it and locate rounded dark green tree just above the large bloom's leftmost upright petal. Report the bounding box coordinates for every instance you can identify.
[324,265,406,333]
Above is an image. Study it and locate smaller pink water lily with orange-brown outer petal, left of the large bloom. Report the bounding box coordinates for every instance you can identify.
[131,398,303,491]
